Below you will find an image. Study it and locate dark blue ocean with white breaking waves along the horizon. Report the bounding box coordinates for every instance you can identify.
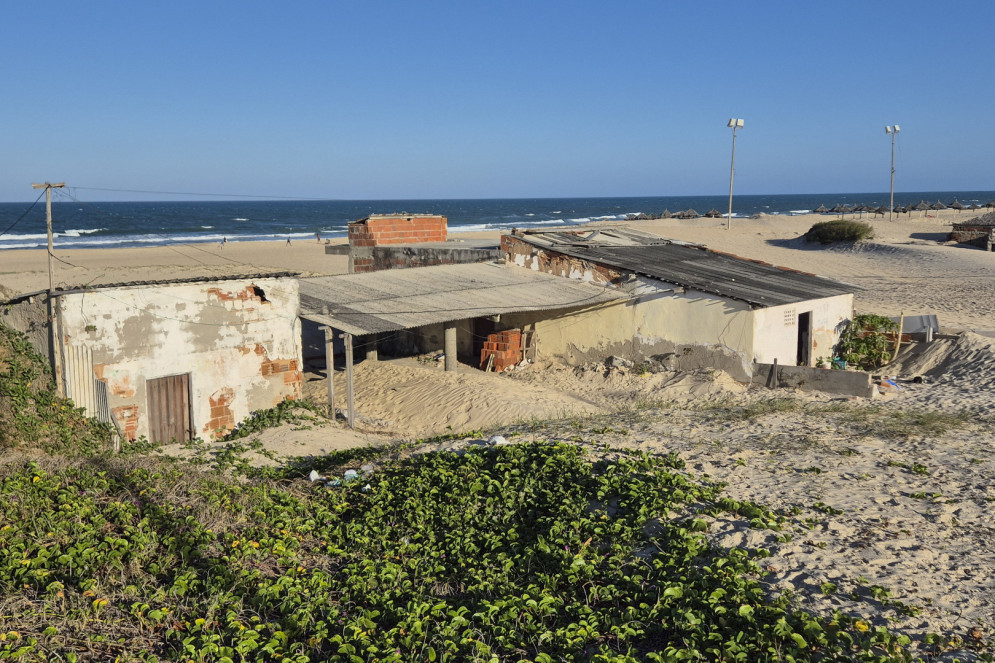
[0,195,995,250]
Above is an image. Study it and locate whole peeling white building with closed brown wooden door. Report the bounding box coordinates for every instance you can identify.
[0,273,302,442]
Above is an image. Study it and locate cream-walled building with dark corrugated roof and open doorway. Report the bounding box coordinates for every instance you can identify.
[502,229,854,378]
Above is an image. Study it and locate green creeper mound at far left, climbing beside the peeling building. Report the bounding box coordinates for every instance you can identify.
[0,324,112,453]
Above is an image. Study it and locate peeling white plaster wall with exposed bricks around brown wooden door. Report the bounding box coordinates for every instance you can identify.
[60,278,302,438]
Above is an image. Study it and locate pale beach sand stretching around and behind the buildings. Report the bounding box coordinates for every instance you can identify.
[7,210,995,660]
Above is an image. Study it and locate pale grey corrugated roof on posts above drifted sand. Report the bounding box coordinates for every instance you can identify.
[300,263,628,334]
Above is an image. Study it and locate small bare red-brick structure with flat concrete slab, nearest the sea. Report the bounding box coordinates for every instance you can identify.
[325,212,501,274]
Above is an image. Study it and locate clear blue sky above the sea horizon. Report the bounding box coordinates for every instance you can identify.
[0,0,995,201]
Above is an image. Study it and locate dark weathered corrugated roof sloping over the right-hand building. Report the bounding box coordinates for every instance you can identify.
[519,231,857,307]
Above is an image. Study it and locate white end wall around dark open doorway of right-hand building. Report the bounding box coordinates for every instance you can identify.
[753,294,853,366]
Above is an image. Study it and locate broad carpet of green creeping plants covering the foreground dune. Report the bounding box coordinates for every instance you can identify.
[0,443,924,663]
